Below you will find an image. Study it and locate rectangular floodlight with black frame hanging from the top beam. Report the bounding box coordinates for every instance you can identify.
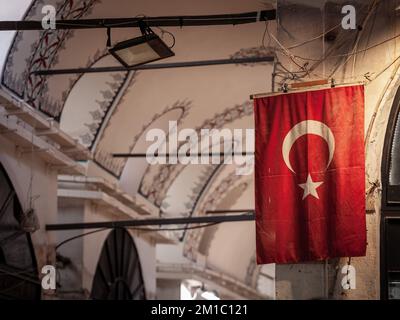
[109,21,175,68]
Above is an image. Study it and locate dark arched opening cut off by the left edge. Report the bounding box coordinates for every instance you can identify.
[0,164,41,300]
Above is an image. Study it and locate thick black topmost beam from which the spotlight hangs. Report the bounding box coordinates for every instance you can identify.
[0,10,276,31]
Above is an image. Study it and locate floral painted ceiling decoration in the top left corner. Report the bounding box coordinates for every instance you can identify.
[2,0,99,119]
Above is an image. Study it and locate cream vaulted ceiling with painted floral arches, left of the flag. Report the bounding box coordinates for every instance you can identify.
[1,0,272,242]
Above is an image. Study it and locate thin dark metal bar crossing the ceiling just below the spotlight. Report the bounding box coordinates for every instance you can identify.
[33,56,274,76]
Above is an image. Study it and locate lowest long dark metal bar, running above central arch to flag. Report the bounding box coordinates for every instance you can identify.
[46,212,255,231]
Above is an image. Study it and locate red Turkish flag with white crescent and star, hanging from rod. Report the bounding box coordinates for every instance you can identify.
[254,86,366,264]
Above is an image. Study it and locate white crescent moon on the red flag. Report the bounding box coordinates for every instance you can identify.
[282,120,335,173]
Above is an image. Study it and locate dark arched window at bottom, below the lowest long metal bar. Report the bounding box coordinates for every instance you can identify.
[91,228,146,300]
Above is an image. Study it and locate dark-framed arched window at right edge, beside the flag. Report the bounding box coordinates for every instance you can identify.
[381,89,400,299]
